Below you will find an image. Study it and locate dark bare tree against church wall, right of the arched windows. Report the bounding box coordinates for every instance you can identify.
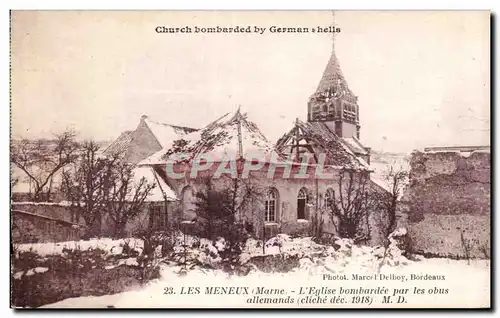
[328,169,380,242]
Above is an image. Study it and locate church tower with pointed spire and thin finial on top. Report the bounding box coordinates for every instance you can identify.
[307,13,360,139]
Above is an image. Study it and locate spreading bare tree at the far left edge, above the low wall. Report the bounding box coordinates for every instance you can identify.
[11,130,79,201]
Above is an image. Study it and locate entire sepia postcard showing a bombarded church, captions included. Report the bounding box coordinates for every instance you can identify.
[10,11,491,309]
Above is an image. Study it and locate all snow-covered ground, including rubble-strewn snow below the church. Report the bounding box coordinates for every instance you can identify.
[23,235,490,308]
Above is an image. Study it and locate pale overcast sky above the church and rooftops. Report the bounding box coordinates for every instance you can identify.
[12,11,490,151]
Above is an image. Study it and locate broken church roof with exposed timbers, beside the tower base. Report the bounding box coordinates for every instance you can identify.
[276,119,370,170]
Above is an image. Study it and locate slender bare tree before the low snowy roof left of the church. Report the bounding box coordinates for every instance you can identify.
[107,161,155,237]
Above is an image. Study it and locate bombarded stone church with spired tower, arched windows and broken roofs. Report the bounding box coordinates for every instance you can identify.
[129,26,386,244]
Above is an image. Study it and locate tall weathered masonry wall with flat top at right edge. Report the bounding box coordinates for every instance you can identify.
[403,151,491,257]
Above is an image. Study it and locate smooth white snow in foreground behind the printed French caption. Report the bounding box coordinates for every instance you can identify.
[44,255,490,308]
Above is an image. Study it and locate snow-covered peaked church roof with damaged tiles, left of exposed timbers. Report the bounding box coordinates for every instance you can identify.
[139,110,282,165]
